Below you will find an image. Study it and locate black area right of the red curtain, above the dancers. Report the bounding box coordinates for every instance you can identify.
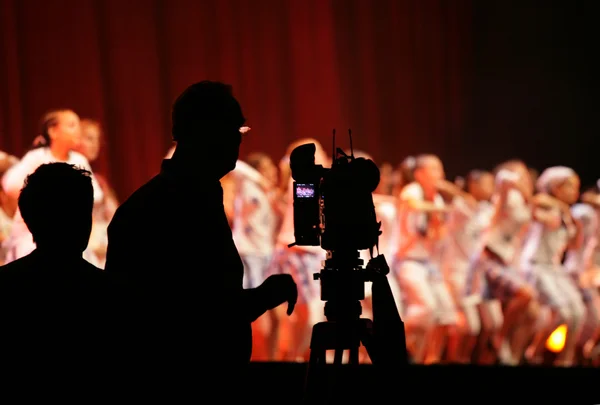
[466,1,600,186]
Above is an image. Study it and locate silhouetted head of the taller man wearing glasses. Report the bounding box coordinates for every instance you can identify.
[172,81,245,179]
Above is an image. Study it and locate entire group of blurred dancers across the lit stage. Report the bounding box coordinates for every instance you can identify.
[0,110,600,366]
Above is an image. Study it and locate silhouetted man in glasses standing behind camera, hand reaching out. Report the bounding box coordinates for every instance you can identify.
[106,81,297,386]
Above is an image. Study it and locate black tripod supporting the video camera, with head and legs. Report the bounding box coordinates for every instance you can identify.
[305,252,407,403]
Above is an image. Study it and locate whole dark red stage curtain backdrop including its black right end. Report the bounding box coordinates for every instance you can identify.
[0,0,600,199]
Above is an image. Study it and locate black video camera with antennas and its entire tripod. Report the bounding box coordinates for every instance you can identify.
[289,130,407,382]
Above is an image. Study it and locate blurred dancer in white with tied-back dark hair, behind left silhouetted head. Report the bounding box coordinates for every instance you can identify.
[2,109,104,263]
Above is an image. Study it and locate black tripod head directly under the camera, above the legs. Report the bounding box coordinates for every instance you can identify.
[313,249,390,321]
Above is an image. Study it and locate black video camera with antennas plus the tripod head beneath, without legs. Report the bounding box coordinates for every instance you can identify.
[290,130,389,320]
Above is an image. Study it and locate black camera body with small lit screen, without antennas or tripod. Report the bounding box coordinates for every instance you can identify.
[290,143,380,252]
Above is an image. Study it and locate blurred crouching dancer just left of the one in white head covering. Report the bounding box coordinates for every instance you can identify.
[466,160,538,364]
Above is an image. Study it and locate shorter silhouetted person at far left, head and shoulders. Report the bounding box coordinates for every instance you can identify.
[0,163,111,364]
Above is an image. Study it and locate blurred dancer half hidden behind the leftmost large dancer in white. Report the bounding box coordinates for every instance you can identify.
[76,119,119,269]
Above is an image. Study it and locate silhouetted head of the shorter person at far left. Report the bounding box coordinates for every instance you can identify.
[19,163,94,255]
